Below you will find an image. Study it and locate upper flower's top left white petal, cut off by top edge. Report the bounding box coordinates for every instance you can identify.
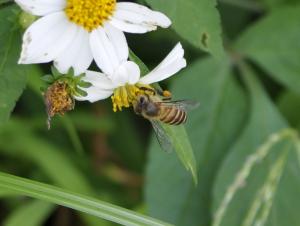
[15,0,66,16]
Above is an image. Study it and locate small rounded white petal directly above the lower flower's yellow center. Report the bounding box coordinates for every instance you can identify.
[110,61,141,86]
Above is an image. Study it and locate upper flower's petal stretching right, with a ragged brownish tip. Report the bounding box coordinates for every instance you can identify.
[110,2,171,33]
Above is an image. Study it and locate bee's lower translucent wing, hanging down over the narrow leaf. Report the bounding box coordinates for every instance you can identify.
[150,120,173,153]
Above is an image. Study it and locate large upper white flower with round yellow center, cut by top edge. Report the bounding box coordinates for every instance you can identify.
[16,0,171,74]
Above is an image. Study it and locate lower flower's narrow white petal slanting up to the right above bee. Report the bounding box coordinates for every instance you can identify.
[139,43,186,84]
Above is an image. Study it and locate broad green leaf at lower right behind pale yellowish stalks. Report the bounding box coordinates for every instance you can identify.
[213,63,300,226]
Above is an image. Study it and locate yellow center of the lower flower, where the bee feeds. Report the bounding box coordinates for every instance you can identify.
[111,84,156,112]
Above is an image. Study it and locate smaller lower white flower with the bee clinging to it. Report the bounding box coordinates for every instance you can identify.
[76,43,186,111]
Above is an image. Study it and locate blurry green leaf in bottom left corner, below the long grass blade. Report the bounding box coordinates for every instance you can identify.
[3,200,54,226]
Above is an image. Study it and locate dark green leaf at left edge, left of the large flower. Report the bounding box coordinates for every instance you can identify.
[0,6,29,125]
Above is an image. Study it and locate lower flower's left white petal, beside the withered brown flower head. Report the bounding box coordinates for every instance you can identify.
[75,86,113,103]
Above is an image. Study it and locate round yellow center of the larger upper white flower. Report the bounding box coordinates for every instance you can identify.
[65,0,116,32]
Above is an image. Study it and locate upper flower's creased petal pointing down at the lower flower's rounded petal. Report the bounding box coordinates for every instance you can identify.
[90,23,129,75]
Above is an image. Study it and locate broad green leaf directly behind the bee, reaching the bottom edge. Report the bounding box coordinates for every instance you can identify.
[146,58,246,226]
